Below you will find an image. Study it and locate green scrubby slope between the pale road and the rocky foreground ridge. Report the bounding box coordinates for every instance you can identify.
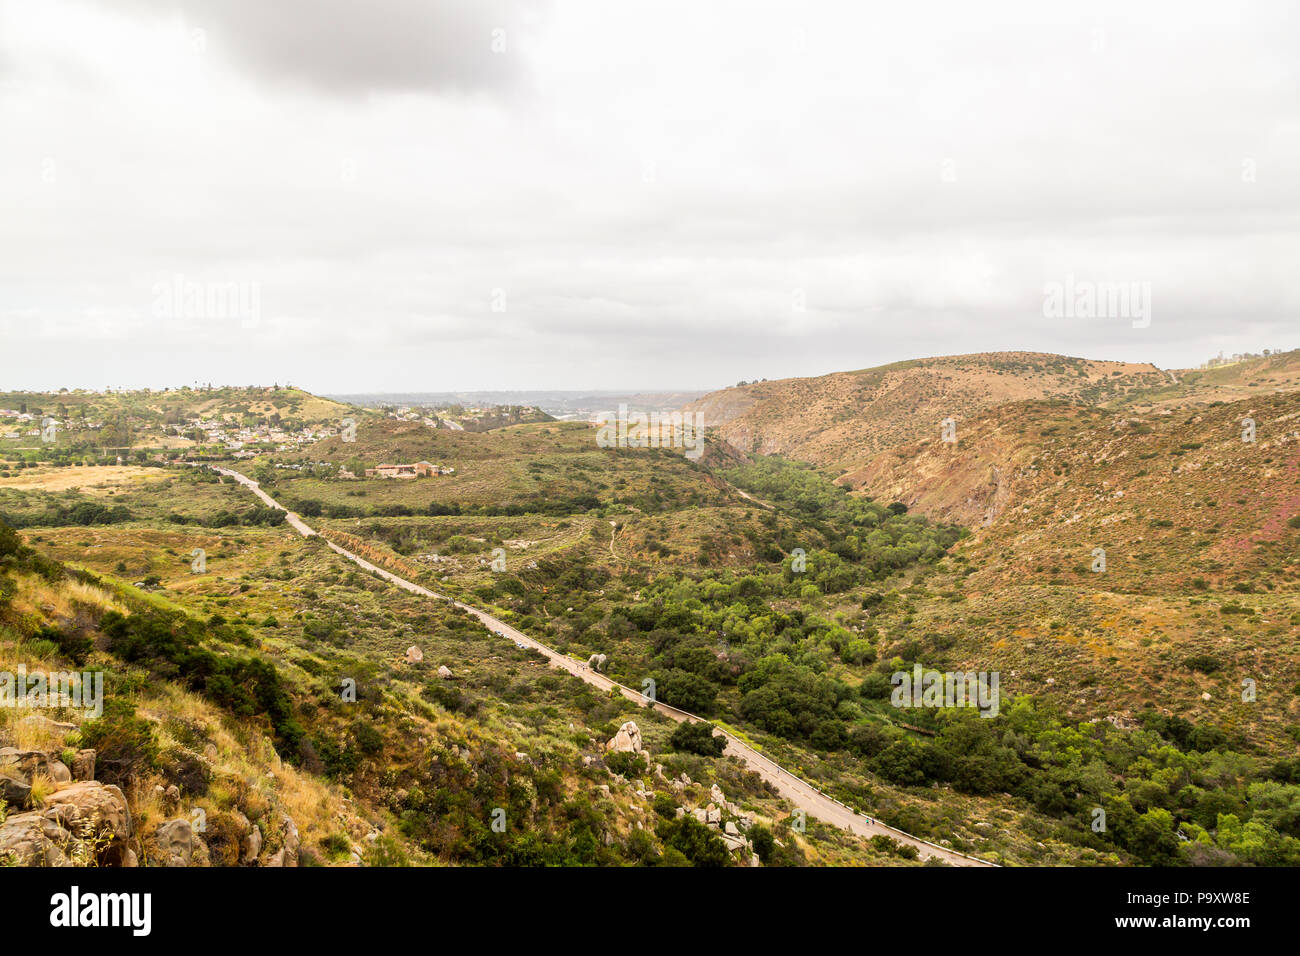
[5,473,897,862]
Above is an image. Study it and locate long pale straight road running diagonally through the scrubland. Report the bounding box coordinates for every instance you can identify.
[209,466,997,866]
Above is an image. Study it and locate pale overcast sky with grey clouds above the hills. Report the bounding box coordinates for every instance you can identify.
[0,0,1300,393]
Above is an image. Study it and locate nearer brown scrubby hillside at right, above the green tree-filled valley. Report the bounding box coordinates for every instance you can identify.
[841,392,1300,753]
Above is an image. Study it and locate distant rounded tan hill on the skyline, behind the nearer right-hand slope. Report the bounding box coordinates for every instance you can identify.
[686,352,1169,471]
